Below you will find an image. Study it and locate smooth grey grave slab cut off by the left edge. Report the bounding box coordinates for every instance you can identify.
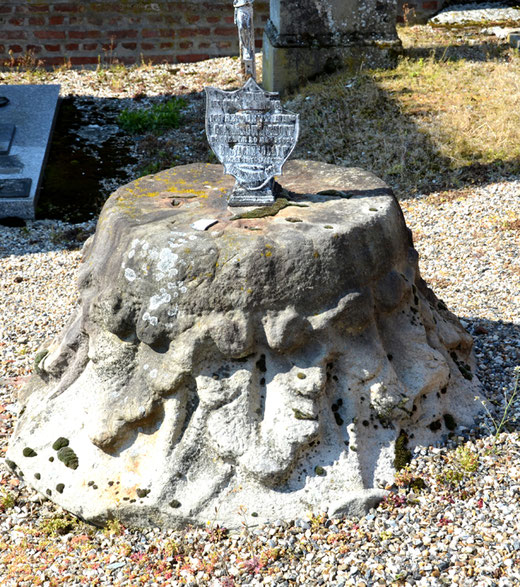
[0,85,60,220]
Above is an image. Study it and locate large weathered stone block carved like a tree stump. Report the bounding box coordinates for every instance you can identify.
[8,161,479,527]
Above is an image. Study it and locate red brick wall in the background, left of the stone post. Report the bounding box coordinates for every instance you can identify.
[0,0,269,66]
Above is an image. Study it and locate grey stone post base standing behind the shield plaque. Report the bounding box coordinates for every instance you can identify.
[263,0,401,93]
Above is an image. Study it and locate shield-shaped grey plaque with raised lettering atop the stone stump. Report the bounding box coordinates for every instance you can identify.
[206,78,299,206]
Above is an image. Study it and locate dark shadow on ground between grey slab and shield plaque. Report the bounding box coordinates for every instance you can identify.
[36,94,209,223]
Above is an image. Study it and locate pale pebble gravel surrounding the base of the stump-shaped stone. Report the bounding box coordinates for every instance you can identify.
[0,41,520,587]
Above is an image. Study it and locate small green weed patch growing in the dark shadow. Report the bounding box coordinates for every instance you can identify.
[117,97,187,135]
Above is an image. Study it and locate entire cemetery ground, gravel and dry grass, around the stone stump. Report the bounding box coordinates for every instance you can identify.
[0,21,520,586]
